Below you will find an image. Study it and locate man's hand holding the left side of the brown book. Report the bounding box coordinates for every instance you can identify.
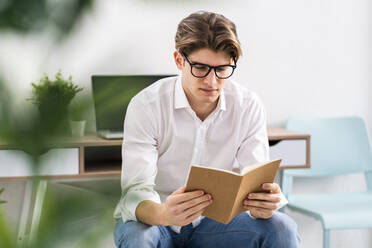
[162,186,212,226]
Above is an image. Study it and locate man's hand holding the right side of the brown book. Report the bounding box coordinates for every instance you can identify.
[243,183,281,219]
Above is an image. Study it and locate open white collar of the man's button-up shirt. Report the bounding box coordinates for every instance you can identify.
[174,76,226,111]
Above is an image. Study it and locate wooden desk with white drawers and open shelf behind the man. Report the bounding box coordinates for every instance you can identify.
[0,128,310,180]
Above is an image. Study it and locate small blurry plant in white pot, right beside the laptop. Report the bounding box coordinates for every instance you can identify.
[69,101,85,137]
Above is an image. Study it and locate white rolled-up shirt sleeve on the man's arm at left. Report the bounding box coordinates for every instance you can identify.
[117,98,161,223]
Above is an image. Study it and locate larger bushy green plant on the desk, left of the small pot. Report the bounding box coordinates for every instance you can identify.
[29,71,83,135]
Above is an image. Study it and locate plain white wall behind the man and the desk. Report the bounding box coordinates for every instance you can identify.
[0,0,372,247]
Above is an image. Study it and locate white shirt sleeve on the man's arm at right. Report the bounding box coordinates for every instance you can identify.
[236,95,288,217]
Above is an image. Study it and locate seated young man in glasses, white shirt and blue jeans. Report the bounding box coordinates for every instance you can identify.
[114,12,299,248]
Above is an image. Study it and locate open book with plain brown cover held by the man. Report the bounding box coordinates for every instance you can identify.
[186,159,281,224]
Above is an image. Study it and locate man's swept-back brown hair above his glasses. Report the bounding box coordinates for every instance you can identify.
[175,11,242,61]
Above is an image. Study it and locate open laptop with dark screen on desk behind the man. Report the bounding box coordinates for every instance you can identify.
[92,75,174,139]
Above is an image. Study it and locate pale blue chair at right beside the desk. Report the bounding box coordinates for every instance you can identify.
[282,117,372,248]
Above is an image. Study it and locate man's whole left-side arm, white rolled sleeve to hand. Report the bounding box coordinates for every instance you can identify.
[119,99,211,226]
